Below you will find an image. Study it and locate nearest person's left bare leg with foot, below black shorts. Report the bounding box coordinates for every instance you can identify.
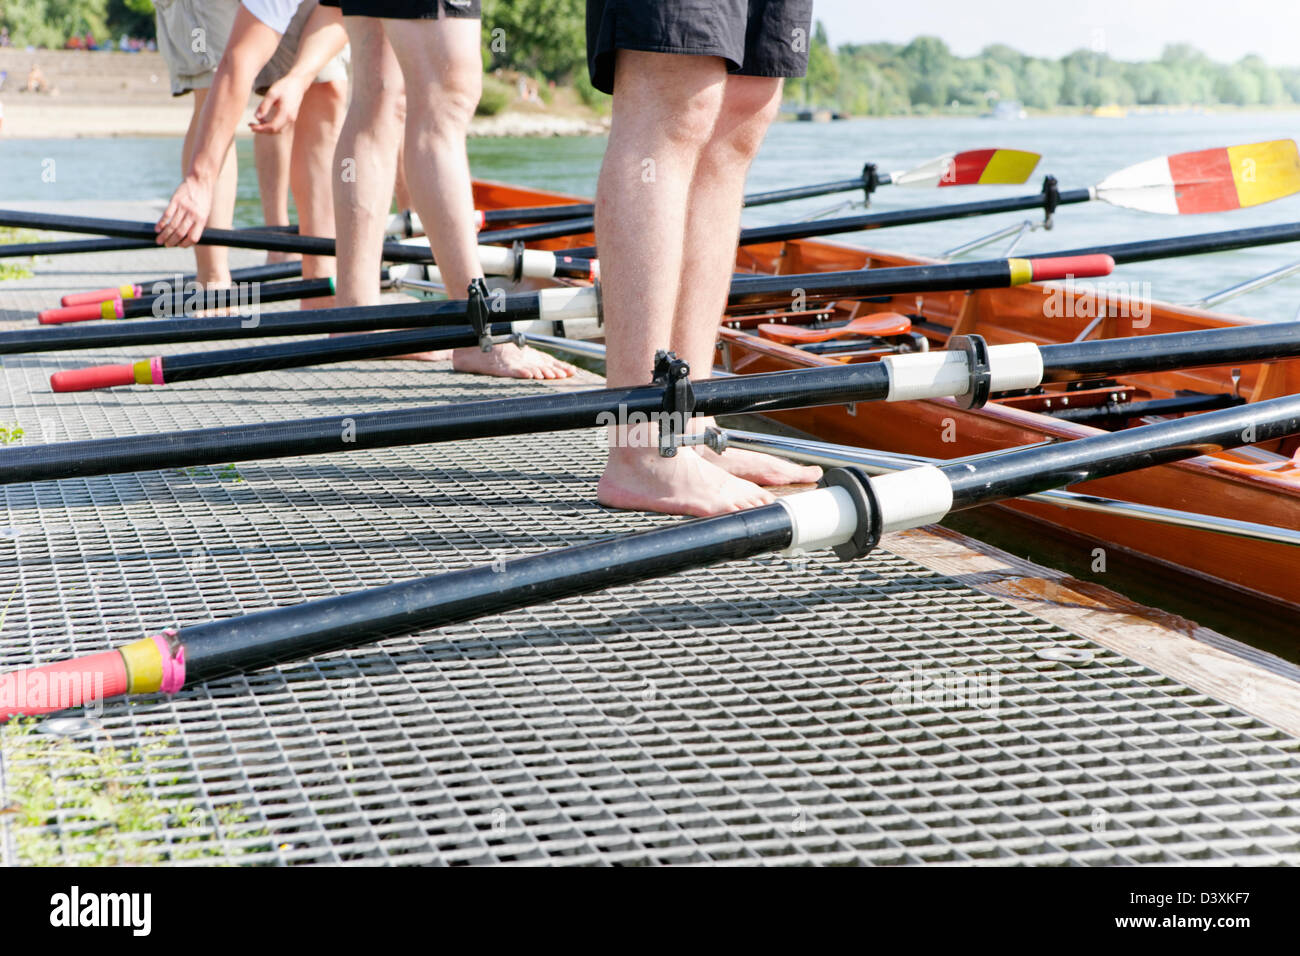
[595,51,771,515]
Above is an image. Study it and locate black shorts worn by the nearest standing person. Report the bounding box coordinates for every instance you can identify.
[586,0,813,92]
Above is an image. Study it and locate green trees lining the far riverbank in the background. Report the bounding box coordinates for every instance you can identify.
[10,0,1300,116]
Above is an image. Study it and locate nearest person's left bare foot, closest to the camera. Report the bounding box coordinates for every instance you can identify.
[595,446,775,518]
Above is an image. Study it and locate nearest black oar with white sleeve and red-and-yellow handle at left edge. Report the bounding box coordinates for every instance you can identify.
[0,392,1300,719]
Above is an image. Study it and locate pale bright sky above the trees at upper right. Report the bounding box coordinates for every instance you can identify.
[813,0,1300,66]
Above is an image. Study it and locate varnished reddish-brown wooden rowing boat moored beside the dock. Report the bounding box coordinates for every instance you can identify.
[475,182,1300,607]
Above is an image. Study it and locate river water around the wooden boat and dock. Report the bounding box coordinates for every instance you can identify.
[0,112,1300,650]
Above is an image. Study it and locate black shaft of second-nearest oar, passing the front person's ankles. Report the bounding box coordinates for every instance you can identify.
[15,314,1300,484]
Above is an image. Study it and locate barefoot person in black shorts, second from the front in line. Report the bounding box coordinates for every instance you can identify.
[332,0,573,378]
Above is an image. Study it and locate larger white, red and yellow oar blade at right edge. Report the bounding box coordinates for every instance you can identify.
[1093,139,1300,216]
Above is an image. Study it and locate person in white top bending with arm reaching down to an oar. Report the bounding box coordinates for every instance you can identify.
[156,0,347,308]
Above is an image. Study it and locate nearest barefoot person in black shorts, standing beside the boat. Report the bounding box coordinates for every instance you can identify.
[586,0,820,515]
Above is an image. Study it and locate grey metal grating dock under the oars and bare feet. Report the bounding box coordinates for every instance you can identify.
[0,247,1300,865]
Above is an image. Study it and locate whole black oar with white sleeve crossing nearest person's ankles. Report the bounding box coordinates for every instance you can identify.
[12,317,1300,484]
